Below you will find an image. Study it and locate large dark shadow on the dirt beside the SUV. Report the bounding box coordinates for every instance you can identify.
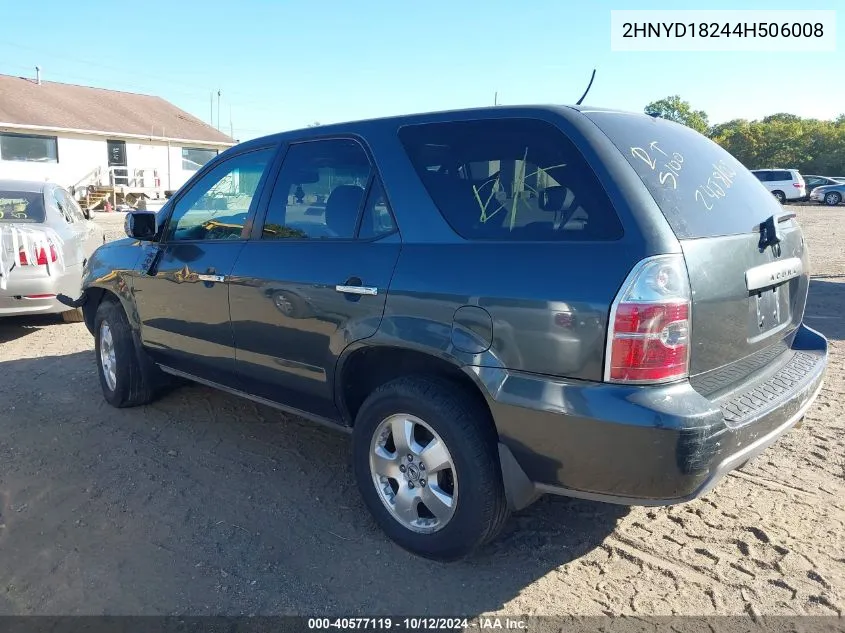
[0,352,627,615]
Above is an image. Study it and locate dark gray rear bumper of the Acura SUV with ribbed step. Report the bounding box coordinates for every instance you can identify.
[478,325,828,508]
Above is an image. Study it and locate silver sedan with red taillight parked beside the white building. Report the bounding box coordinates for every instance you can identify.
[0,180,105,321]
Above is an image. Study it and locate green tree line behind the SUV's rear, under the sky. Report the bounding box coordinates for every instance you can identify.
[645,95,845,176]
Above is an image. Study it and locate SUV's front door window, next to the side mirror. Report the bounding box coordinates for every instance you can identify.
[168,148,275,241]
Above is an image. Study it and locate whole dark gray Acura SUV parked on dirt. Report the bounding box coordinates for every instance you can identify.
[65,107,827,559]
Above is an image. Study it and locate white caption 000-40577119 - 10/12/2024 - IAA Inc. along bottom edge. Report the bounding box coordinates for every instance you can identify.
[308,616,528,631]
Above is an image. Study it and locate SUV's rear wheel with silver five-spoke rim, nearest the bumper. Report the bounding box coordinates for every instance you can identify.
[352,377,508,561]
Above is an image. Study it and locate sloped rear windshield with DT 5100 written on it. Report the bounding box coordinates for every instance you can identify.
[587,112,782,239]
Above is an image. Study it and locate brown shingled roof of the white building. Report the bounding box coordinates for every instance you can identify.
[0,75,235,145]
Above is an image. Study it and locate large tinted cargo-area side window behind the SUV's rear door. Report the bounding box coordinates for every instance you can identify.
[399,118,622,241]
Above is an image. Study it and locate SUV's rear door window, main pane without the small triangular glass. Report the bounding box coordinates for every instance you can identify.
[261,139,372,239]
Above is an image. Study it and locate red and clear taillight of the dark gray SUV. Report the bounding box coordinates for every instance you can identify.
[604,255,690,384]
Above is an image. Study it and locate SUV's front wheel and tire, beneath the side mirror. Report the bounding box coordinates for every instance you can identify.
[94,299,160,408]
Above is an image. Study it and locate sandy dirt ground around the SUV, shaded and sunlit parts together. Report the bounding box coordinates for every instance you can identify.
[0,206,845,616]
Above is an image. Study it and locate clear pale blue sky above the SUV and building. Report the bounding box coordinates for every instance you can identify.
[0,0,845,140]
